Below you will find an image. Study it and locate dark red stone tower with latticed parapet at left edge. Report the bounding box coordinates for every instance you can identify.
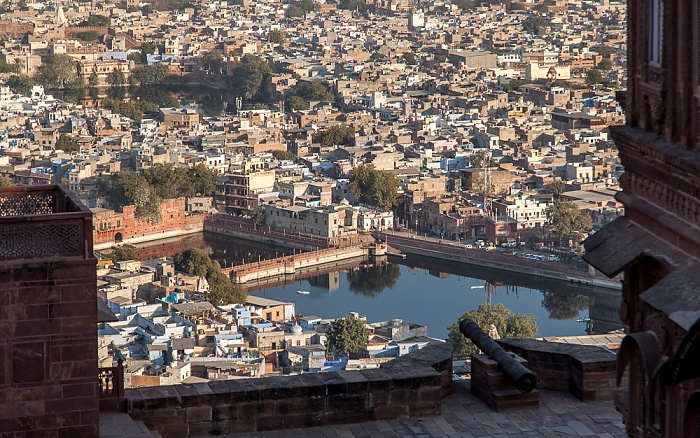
[0,186,99,438]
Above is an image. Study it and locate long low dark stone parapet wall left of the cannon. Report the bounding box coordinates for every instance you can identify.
[126,344,452,438]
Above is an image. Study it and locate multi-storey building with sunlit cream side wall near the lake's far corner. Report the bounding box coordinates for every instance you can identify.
[216,170,275,215]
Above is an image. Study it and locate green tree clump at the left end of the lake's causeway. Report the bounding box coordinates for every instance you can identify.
[173,249,247,306]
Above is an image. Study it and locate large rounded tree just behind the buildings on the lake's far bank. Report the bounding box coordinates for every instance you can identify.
[348,166,399,210]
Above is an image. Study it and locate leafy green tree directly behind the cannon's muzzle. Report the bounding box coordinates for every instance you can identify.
[447,303,539,356]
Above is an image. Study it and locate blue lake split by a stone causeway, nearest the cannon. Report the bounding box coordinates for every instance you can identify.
[133,233,622,339]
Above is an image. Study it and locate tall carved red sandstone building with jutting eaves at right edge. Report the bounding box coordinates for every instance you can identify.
[585,0,700,437]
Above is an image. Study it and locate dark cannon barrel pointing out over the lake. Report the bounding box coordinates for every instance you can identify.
[459,318,537,392]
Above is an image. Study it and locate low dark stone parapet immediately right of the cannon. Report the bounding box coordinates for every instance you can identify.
[496,339,617,402]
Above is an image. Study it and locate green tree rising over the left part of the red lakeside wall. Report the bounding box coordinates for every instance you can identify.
[102,170,161,222]
